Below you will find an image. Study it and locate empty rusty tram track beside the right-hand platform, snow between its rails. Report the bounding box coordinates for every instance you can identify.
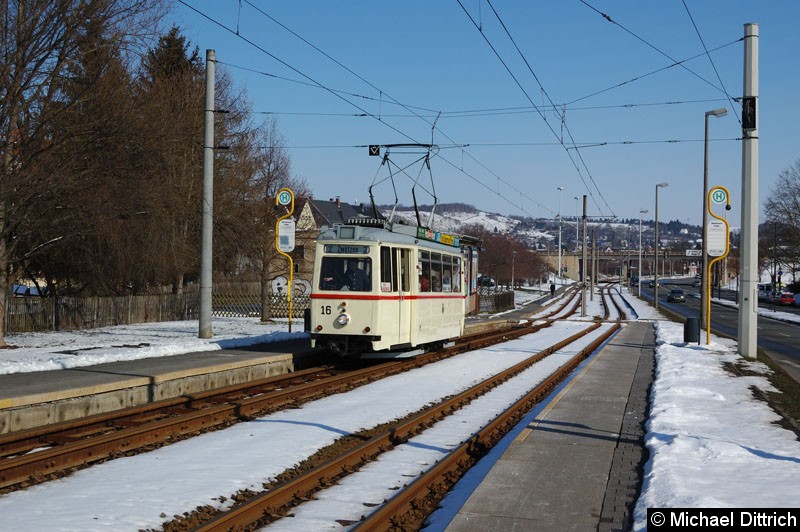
[181,294,624,531]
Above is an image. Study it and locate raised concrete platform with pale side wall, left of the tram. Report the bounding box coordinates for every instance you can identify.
[0,340,315,434]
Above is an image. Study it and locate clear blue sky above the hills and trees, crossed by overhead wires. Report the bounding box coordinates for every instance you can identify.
[170,0,800,226]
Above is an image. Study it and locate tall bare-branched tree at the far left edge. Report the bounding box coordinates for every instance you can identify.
[0,0,160,347]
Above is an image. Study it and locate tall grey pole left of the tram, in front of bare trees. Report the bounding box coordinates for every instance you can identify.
[198,50,216,338]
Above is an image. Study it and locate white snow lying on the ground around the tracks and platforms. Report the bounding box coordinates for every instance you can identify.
[0,289,800,532]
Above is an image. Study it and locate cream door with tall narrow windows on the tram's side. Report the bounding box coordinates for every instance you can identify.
[381,246,412,346]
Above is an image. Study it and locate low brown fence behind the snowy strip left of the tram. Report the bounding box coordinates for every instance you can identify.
[3,286,309,333]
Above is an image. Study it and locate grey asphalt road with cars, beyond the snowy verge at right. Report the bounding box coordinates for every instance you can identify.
[631,280,800,382]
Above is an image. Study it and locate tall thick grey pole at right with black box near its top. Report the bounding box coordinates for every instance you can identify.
[738,23,759,359]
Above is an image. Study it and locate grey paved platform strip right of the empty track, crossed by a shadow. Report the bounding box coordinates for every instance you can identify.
[446,322,655,532]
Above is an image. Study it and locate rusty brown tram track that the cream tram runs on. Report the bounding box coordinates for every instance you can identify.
[0,292,577,492]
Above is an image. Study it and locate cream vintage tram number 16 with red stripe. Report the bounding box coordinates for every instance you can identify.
[309,218,473,358]
